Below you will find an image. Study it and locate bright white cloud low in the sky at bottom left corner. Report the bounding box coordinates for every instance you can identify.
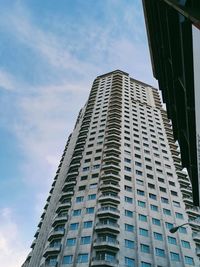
[0,208,28,267]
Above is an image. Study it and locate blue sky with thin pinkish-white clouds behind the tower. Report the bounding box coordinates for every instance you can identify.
[0,0,157,267]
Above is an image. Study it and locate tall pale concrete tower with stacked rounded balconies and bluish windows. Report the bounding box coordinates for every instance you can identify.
[23,70,200,267]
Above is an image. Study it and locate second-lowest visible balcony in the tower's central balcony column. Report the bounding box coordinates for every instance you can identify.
[93,239,119,250]
